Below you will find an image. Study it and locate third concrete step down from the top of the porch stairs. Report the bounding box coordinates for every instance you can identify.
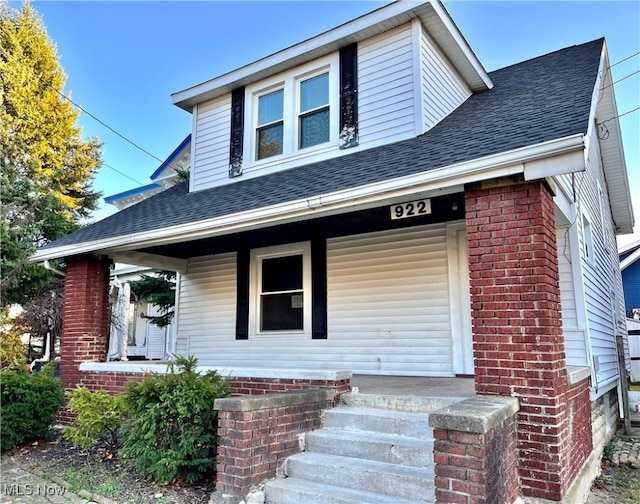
[307,428,433,467]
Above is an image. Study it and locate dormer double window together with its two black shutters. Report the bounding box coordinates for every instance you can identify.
[229,44,358,177]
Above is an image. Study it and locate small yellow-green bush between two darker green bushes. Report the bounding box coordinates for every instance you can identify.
[64,386,126,454]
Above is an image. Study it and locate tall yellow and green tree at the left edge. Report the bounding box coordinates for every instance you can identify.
[0,3,101,305]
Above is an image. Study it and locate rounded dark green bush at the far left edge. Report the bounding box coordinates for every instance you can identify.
[0,363,64,451]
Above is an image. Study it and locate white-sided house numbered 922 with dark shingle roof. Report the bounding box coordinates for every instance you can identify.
[33,1,633,500]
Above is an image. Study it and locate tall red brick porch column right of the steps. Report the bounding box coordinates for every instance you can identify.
[465,181,591,500]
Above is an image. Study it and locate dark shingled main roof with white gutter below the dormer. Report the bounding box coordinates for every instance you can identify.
[32,39,604,261]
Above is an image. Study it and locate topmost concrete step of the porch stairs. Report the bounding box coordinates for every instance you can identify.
[340,392,468,413]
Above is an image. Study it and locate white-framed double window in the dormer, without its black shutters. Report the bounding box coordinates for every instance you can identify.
[244,54,339,162]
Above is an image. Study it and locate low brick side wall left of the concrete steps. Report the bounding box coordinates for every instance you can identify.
[214,389,335,496]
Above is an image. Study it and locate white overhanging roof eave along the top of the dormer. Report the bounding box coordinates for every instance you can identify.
[171,0,493,112]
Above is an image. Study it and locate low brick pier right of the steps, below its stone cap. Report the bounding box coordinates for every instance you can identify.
[434,417,518,504]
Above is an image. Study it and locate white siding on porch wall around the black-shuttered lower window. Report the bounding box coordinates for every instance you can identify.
[177,226,452,376]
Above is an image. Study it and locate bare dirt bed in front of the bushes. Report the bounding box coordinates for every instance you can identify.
[2,431,215,504]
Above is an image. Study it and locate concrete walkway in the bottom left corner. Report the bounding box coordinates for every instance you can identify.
[0,456,101,504]
